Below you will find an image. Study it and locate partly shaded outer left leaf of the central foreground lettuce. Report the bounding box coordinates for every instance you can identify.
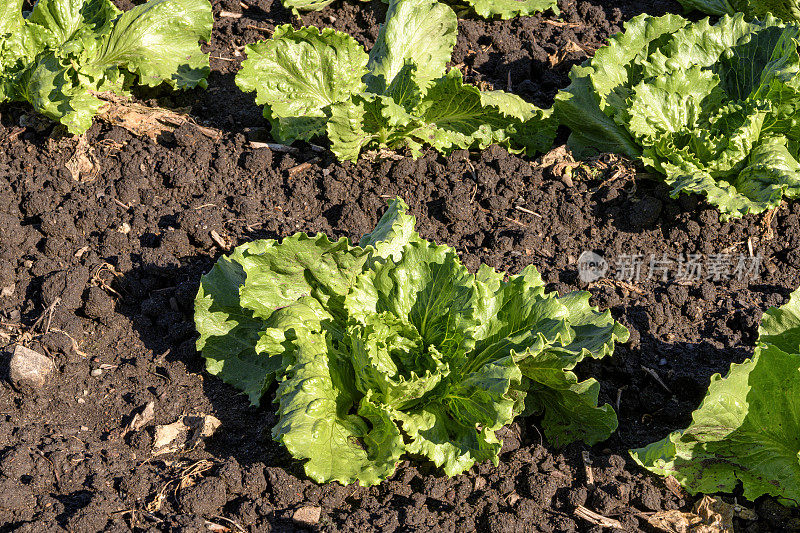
[194,240,280,405]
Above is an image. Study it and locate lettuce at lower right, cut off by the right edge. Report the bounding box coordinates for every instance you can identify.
[631,290,800,506]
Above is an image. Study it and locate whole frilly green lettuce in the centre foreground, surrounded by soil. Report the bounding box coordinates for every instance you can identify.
[195,200,628,485]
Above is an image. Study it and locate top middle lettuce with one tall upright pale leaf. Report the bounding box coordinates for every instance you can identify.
[236,0,555,161]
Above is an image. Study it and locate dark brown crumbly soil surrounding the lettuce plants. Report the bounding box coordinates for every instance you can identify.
[0,0,800,533]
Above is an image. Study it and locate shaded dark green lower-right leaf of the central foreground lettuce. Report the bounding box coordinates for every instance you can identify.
[519,351,617,446]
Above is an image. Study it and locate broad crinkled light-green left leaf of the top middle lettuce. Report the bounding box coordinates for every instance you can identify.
[236,24,367,142]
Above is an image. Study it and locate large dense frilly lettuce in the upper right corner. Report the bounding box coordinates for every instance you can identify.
[554,14,800,218]
